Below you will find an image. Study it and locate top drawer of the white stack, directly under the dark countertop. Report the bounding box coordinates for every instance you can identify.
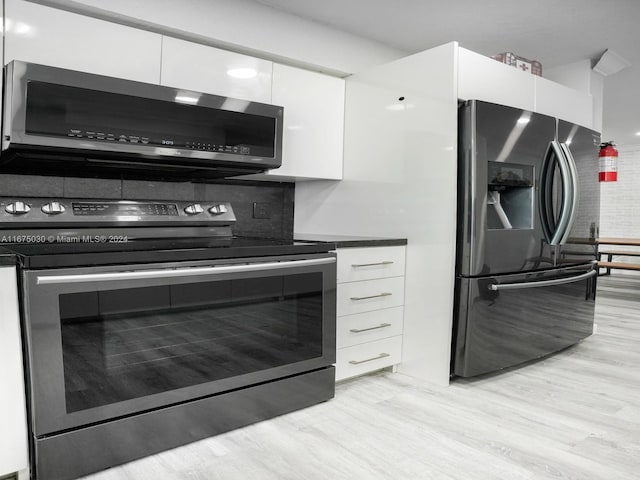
[337,246,405,283]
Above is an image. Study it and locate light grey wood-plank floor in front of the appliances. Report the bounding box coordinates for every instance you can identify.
[85,276,640,480]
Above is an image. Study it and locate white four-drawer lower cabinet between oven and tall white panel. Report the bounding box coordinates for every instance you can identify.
[336,246,405,381]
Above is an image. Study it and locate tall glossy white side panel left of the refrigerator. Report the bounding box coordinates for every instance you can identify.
[295,43,458,385]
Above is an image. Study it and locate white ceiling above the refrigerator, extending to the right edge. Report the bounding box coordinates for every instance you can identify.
[257,0,640,146]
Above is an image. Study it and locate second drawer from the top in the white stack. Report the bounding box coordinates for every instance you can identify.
[337,277,404,316]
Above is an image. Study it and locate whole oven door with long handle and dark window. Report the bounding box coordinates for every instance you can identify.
[23,253,336,436]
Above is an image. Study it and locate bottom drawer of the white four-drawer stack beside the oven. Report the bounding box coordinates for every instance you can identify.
[336,335,402,381]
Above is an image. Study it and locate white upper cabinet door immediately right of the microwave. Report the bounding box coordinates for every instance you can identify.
[269,63,344,180]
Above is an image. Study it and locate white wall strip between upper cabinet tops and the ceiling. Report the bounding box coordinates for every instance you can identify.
[31,0,406,75]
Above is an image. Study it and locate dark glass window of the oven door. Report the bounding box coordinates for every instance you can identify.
[58,272,323,413]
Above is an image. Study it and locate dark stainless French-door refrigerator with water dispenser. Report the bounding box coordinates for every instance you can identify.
[451,100,600,377]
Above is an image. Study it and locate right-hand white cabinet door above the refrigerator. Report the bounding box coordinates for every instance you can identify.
[535,77,593,128]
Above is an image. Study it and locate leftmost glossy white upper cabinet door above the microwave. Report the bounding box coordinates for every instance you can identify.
[4,0,162,84]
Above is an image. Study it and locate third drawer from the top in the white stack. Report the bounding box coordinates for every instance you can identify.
[336,307,404,348]
